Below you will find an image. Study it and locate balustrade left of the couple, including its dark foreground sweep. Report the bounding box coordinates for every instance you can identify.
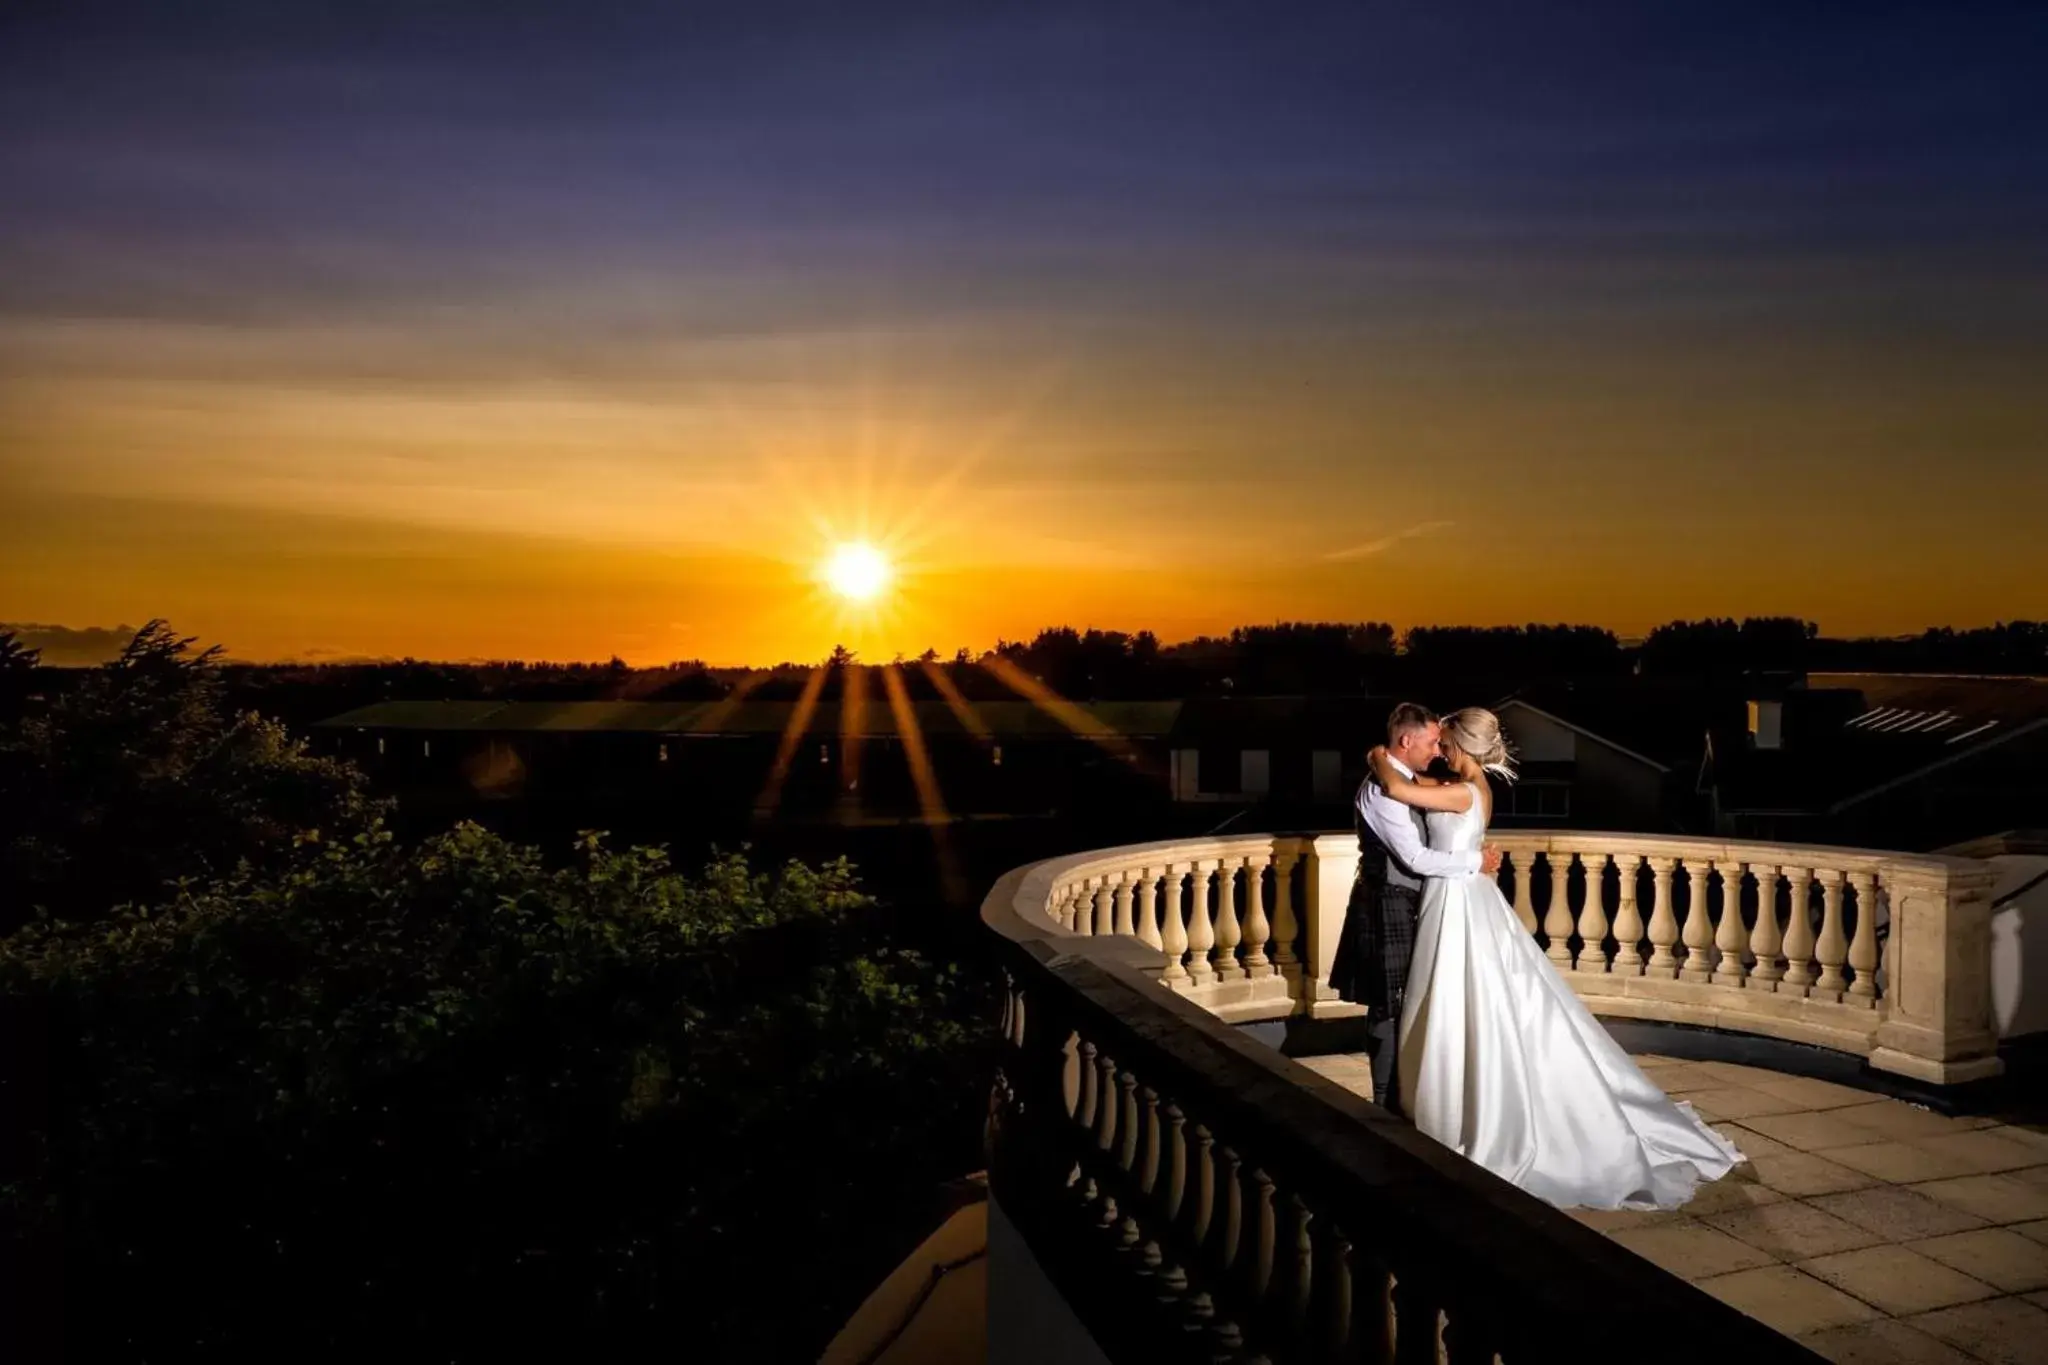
[983,859,1826,1365]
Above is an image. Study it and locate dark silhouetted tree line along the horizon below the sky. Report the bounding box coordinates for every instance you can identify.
[0,616,2048,724]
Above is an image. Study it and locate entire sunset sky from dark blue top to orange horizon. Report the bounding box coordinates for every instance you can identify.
[0,0,2048,663]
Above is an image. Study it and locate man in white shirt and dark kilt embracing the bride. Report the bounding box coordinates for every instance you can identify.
[1331,702,1501,1113]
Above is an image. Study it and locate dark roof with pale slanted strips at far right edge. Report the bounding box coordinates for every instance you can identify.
[1714,673,2048,812]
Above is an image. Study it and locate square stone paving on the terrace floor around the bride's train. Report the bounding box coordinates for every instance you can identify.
[1303,1056,2048,1365]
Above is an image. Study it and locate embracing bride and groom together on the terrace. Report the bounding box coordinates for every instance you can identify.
[1333,704,1743,1209]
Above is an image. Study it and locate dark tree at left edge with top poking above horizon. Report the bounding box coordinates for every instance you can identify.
[0,620,379,931]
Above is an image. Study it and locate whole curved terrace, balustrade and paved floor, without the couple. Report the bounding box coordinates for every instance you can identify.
[983,831,2048,1361]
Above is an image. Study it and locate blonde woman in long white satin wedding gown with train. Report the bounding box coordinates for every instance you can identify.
[1370,706,1745,1209]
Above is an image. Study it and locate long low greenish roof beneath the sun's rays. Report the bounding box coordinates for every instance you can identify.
[317,694,1180,739]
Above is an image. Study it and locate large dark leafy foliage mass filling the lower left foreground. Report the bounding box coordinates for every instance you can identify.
[0,825,983,1359]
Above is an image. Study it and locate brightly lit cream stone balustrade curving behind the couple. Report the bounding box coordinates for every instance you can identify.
[1022,831,1999,1085]
